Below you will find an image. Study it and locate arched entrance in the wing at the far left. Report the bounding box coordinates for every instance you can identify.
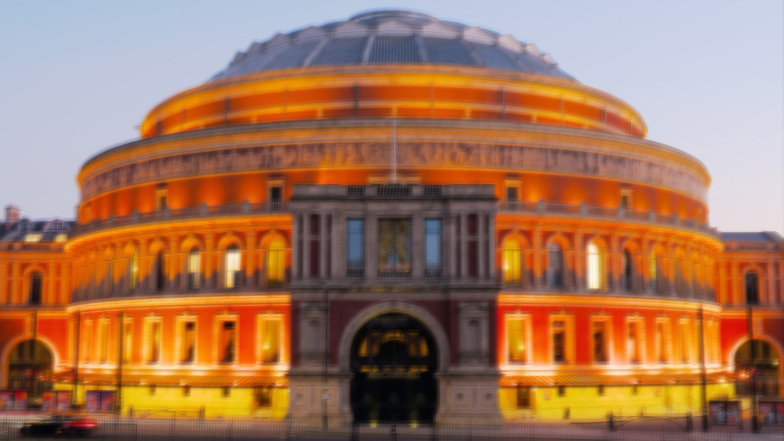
[6,339,54,401]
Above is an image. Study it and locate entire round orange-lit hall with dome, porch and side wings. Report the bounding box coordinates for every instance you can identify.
[0,10,784,424]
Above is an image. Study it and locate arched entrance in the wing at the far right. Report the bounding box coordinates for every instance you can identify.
[733,340,781,397]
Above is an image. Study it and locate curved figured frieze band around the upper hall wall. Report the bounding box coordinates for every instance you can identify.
[82,141,706,200]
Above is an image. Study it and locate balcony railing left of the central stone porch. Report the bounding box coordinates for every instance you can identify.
[70,202,288,237]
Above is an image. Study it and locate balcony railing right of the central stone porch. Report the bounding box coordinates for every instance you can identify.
[498,201,720,238]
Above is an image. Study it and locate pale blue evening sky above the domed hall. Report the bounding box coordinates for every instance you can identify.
[0,0,784,233]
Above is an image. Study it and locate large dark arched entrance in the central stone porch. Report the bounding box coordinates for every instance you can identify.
[350,313,438,424]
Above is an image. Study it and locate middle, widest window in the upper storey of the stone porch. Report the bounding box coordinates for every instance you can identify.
[378,219,411,277]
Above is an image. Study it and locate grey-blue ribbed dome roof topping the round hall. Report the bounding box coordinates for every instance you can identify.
[211,10,574,81]
